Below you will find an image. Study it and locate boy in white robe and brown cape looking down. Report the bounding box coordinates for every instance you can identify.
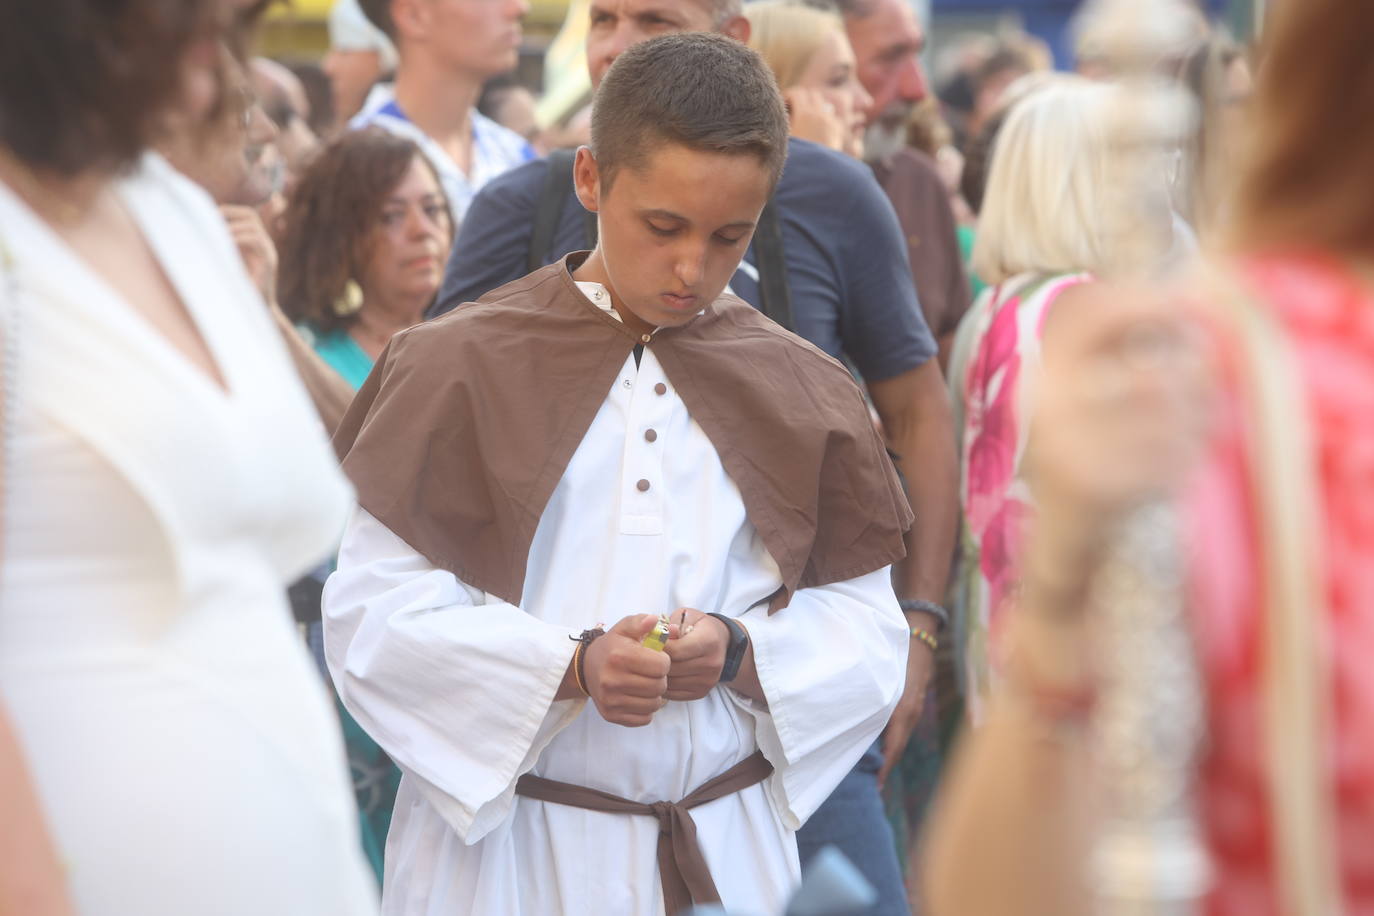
[324,34,911,916]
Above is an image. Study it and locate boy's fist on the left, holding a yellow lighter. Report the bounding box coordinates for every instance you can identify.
[583,614,673,728]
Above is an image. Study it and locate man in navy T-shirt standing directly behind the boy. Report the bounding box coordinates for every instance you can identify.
[430,0,958,916]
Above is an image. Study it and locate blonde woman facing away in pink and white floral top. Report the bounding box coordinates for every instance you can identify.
[948,77,1168,718]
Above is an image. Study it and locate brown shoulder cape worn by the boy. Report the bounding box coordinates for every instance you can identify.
[334,253,912,610]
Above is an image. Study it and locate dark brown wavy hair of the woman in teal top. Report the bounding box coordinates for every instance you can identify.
[276,128,448,332]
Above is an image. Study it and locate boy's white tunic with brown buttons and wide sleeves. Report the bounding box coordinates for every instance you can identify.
[324,317,908,916]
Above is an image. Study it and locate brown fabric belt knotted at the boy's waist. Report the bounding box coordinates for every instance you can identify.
[515,751,772,916]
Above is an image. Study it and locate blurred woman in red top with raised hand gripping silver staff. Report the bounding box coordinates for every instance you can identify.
[927,0,1374,916]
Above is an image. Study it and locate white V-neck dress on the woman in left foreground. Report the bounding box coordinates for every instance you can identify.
[0,155,376,916]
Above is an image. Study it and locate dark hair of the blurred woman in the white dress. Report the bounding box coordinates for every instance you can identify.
[0,0,229,177]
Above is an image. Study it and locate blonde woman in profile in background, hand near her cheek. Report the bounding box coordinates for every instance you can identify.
[745,0,872,159]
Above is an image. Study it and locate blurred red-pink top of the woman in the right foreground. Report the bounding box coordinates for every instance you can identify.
[1187,257,1374,916]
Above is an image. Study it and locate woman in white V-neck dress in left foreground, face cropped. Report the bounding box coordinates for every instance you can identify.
[0,0,376,916]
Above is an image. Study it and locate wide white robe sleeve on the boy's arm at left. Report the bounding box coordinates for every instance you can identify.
[323,508,585,845]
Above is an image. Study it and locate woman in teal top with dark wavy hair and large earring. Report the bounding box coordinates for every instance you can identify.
[278,128,453,882]
